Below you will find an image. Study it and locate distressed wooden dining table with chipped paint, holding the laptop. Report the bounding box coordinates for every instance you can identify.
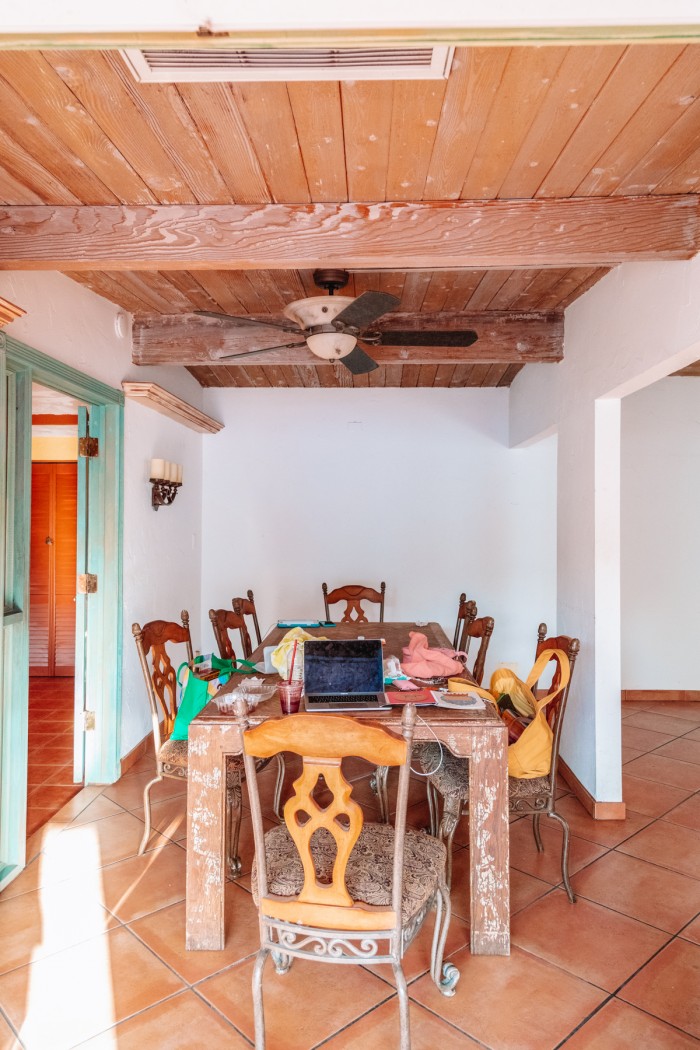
[187,623,510,956]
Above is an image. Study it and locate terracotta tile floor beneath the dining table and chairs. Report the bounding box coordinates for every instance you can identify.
[0,704,700,1050]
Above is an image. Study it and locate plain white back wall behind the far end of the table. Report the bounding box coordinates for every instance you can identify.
[203,389,556,673]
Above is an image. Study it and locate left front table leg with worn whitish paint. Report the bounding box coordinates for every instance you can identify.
[186,721,226,951]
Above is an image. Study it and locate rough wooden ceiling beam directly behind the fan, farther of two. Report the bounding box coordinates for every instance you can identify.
[132,312,564,368]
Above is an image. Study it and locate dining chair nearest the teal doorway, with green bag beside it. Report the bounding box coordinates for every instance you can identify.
[131,609,243,878]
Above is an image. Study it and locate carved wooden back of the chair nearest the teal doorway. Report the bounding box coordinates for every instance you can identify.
[131,609,193,754]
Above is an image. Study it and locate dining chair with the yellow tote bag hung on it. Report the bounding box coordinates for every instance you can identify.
[416,624,580,904]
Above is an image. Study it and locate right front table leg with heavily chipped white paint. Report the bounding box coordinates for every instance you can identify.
[469,728,510,956]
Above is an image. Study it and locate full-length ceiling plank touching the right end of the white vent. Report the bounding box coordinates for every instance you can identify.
[423,47,510,201]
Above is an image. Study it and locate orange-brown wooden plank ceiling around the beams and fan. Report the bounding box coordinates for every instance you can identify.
[0,44,700,386]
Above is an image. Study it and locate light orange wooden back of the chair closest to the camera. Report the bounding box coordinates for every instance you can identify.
[241,701,416,930]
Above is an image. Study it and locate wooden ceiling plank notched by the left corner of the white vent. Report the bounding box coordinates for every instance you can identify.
[105,53,234,204]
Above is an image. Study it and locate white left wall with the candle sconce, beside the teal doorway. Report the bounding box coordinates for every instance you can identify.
[0,273,201,755]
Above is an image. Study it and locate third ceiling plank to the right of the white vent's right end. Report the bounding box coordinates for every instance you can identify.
[497,46,624,197]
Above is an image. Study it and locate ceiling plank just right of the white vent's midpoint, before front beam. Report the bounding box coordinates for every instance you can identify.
[288,81,348,202]
